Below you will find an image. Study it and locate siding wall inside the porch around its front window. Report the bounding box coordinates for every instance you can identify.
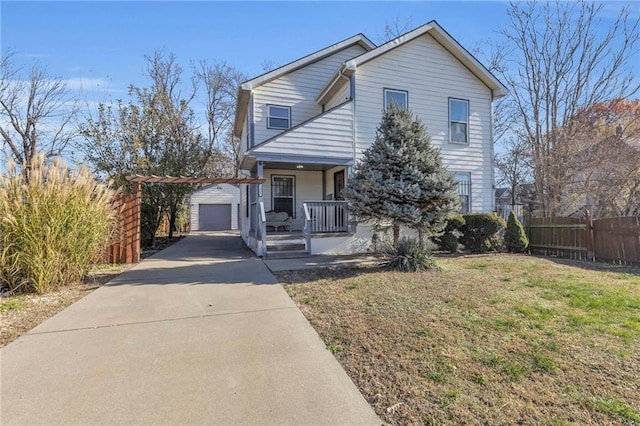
[263,169,322,230]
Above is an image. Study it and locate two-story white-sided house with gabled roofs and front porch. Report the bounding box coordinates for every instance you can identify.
[234,21,507,256]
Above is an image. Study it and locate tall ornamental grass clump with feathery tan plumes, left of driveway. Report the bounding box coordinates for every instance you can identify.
[0,155,115,293]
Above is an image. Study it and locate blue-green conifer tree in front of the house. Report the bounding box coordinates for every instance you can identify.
[344,107,459,245]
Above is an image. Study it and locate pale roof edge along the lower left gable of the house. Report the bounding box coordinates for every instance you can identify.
[234,33,376,135]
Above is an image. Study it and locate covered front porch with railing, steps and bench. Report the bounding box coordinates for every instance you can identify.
[241,159,355,257]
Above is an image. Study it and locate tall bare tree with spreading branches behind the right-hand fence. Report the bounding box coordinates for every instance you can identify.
[497,1,640,215]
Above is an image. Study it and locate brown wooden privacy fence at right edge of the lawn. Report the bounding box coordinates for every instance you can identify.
[526,216,640,264]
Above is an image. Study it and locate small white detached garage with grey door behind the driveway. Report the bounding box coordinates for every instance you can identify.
[190,183,240,231]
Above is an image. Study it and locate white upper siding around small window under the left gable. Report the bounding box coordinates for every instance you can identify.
[253,44,365,144]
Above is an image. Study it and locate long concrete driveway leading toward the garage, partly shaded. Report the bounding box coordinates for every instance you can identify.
[0,233,381,425]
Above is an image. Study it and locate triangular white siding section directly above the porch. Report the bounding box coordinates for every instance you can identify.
[252,102,353,158]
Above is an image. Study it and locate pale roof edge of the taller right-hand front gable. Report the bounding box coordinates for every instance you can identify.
[316,21,508,103]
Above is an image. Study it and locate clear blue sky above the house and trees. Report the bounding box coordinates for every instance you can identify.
[0,0,640,110]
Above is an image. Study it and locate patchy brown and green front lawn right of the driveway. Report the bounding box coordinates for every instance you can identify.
[278,255,640,424]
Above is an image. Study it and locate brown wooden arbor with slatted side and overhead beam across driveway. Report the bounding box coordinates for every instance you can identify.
[107,175,265,263]
